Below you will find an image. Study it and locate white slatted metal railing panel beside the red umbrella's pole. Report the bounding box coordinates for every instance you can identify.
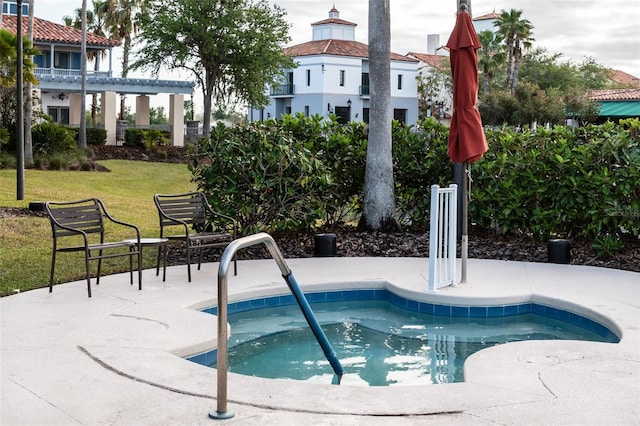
[429,184,458,291]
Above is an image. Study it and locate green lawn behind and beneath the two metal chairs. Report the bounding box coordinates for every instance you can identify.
[0,160,195,296]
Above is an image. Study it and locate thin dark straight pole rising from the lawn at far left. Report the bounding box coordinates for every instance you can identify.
[16,0,24,200]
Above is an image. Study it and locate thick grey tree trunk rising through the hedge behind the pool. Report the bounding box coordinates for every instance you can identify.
[358,0,399,232]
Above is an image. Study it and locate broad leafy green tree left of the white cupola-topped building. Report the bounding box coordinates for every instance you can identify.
[132,0,294,134]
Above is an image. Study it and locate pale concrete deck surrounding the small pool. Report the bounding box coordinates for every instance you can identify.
[0,258,640,426]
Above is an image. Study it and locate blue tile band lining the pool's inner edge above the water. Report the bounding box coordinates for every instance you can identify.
[185,289,620,365]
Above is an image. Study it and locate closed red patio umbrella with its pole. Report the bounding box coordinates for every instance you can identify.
[447,4,488,283]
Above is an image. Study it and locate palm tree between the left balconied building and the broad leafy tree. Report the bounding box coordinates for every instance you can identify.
[106,0,145,120]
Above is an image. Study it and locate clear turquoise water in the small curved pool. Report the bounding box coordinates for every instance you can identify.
[213,300,606,386]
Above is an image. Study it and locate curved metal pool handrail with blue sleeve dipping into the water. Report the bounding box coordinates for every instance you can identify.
[209,232,343,419]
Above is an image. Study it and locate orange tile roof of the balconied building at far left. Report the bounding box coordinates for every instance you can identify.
[2,15,120,47]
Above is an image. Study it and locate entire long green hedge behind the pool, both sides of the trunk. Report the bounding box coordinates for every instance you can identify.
[190,115,640,246]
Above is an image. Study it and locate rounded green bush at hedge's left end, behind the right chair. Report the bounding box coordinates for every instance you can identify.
[189,120,332,234]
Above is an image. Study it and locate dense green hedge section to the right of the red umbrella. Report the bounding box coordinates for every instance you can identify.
[469,120,640,246]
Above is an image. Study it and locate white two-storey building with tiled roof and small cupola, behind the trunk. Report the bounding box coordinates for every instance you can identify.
[248,7,418,125]
